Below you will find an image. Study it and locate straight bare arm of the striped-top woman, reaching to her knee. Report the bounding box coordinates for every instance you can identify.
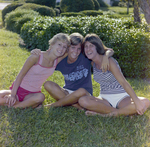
[109,58,144,115]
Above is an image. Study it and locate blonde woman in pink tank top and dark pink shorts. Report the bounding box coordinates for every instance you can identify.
[0,33,70,108]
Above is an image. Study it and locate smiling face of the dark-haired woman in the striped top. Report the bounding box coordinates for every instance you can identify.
[84,41,98,60]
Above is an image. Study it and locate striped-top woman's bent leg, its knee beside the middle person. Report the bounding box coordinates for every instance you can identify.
[78,96,116,115]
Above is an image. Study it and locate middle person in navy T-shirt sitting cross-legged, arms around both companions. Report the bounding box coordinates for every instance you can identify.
[31,33,113,109]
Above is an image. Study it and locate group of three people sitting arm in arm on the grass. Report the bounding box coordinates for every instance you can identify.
[0,33,150,116]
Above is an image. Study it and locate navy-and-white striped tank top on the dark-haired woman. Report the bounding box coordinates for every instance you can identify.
[93,60,126,94]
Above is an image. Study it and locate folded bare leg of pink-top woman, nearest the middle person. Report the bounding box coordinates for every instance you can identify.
[13,93,45,108]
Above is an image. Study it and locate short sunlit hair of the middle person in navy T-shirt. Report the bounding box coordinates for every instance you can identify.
[70,33,83,45]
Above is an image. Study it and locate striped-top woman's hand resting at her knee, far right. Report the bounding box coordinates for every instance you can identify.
[135,99,146,115]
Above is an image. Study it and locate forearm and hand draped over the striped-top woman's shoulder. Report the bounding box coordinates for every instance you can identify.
[101,48,114,72]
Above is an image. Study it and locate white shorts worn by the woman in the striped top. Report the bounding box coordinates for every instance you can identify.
[98,92,129,108]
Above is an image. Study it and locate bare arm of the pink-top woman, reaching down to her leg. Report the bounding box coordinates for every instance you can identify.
[7,55,39,106]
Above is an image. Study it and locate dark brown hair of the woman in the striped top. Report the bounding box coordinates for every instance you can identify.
[83,33,106,55]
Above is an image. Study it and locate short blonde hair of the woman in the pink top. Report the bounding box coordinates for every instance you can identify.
[49,33,71,47]
